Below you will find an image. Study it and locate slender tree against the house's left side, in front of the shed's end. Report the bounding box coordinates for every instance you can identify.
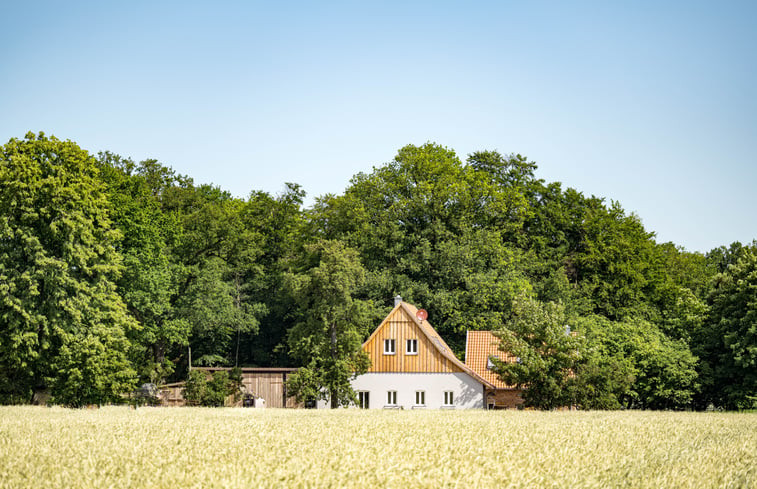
[288,240,371,408]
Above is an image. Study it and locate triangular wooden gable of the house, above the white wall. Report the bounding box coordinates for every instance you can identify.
[363,302,467,373]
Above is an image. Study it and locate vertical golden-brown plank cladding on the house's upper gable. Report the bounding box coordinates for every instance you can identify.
[363,308,462,373]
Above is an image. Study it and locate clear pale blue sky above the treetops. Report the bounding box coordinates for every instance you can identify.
[0,0,757,251]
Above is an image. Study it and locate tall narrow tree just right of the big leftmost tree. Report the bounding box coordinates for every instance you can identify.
[98,152,191,384]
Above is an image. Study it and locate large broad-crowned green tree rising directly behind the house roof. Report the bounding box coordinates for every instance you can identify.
[309,143,530,352]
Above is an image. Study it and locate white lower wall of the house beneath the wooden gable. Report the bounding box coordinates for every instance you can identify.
[346,373,484,409]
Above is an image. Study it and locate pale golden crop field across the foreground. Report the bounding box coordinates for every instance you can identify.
[0,407,757,489]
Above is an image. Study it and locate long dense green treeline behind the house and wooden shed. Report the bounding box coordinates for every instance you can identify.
[0,133,757,409]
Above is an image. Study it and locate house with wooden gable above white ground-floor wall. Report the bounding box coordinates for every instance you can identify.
[344,296,495,409]
